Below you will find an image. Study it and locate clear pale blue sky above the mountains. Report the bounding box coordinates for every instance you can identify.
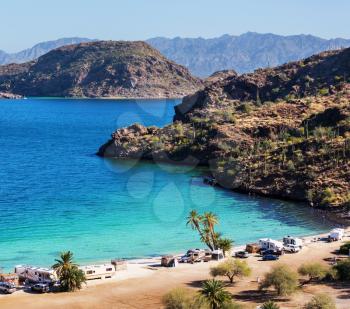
[0,0,350,52]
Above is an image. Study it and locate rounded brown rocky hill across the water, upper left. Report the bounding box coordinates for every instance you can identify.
[0,41,202,98]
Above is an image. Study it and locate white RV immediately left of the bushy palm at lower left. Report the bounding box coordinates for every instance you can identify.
[15,265,57,283]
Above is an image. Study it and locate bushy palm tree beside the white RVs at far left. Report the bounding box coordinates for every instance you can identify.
[52,251,86,292]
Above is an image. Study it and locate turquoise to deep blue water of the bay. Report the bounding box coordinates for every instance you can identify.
[0,99,329,270]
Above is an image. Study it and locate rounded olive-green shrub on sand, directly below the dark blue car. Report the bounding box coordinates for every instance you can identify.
[259,265,298,296]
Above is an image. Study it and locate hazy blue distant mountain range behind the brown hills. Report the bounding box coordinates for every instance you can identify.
[0,32,350,77]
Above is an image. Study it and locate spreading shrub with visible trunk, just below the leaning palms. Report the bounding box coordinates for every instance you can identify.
[210,258,251,283]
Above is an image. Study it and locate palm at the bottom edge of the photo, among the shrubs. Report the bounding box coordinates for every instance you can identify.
[200,279,231,309]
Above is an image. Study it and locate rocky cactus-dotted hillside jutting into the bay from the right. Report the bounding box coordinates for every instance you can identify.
[99,49,350,209]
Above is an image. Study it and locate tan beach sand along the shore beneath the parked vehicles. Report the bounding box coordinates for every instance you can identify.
[0,230,350,309]
